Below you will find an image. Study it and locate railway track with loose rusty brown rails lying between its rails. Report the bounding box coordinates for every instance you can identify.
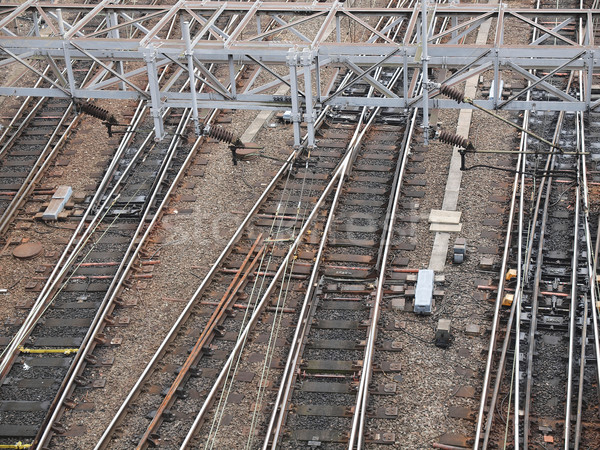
[94,101,380,447]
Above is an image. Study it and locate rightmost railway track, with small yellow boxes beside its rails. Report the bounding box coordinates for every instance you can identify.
[475,0,600,448]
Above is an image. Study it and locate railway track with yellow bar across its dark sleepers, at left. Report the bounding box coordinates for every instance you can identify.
[2,93,193,448]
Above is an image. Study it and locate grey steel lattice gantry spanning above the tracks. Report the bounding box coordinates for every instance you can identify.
[0,0,600,145]
